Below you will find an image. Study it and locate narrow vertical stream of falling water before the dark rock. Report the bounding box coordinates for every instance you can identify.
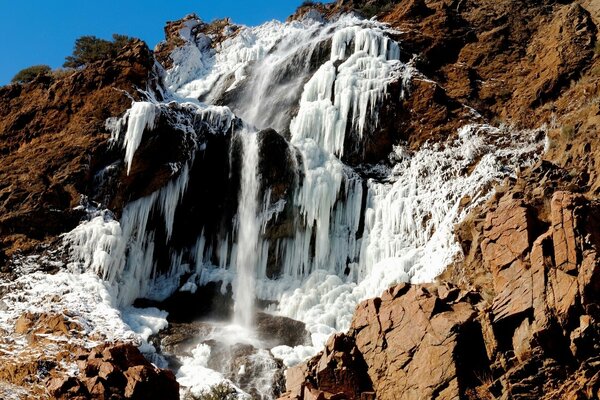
[233,132,261,328]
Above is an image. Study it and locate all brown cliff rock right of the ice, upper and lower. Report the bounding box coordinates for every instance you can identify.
[276,0,600,399]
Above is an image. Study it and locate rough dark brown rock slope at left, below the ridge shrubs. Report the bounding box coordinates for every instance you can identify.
[0,41,154,257]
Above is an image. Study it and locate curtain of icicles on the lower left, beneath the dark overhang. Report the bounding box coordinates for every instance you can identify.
[64,165,189,306]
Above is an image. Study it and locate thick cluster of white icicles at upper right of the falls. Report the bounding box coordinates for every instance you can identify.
[290,22,403,156]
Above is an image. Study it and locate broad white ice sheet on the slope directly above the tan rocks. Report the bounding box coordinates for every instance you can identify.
[275,125,543,365]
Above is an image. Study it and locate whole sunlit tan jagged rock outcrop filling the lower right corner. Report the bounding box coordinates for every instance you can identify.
[284,182,600,399]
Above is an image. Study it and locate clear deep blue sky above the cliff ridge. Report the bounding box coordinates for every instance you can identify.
[0,0,328,85]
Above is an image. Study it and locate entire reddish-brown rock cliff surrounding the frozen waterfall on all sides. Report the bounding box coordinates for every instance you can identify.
[0,0,600,400]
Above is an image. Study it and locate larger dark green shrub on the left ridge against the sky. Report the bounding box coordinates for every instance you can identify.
[63,33,133,68]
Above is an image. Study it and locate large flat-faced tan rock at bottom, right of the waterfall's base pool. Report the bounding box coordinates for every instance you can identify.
[287,284,486,399]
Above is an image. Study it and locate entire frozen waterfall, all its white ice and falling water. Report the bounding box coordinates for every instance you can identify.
[0,10,542,399]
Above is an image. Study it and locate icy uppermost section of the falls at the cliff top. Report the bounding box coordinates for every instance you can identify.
[165,15,400,134]
